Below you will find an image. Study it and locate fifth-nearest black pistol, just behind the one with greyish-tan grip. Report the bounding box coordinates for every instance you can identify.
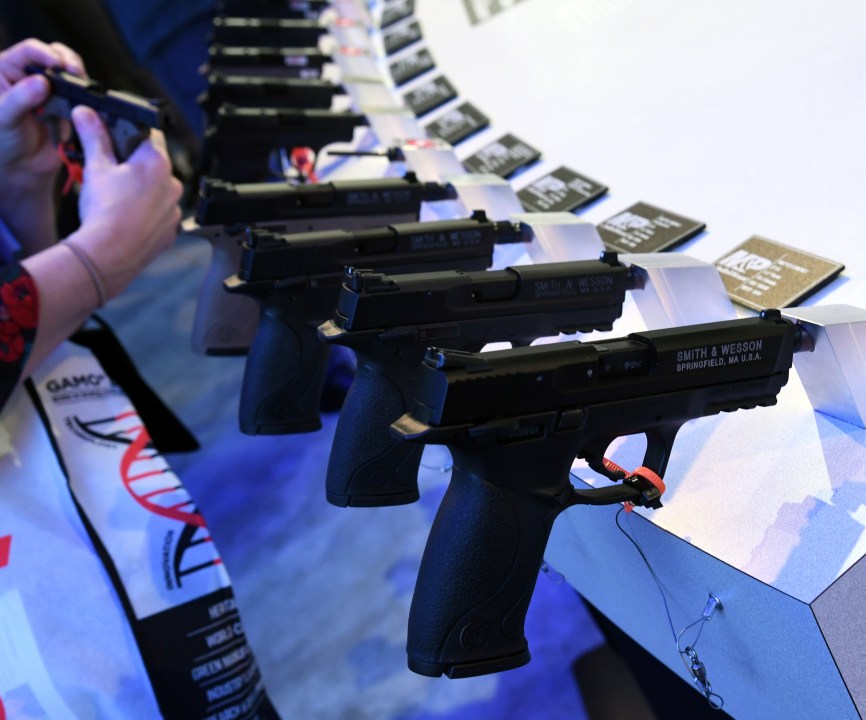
[201,105,367,182]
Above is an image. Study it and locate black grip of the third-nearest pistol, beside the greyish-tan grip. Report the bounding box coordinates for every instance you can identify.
[240,307,329,435]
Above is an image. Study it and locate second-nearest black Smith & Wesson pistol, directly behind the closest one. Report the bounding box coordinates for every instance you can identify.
[319,253,632,507]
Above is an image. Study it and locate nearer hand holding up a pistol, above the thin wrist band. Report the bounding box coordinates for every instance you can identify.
[66,106,183,300]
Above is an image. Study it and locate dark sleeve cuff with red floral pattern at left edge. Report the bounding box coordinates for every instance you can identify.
[0,263,39,410]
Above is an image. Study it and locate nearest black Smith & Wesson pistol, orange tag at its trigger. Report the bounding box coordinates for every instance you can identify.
[392,310,810,677]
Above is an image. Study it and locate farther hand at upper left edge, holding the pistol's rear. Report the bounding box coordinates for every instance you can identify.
[0,39,85,192]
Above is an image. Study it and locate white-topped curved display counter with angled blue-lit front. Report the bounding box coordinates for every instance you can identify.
[406,0,866,718]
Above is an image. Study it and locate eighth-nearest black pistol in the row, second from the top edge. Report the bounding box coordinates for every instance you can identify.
[210,16,328,47]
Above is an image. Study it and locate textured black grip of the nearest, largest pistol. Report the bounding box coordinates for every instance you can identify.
[406,458,558,678]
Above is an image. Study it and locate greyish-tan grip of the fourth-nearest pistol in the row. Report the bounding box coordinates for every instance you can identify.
[192,233,259,355]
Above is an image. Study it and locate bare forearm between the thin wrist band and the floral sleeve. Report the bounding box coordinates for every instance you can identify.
[21,243,99,377]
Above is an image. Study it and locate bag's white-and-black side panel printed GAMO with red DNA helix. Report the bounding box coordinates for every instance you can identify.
[32,343,277,720]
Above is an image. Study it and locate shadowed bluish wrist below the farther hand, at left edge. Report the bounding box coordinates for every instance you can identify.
[0,178,57,257]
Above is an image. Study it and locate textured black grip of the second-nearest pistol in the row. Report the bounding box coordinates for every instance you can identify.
[326,363,424,507]
